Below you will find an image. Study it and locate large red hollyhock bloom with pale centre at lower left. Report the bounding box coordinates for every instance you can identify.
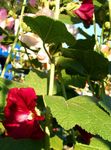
[3,88,45,139]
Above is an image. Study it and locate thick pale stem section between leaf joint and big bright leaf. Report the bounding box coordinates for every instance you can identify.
[48,61,55,96]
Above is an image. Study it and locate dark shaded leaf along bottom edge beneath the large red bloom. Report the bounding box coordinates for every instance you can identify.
[0,138,44,150]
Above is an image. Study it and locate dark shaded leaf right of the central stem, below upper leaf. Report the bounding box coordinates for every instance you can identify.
[62,48,109,80]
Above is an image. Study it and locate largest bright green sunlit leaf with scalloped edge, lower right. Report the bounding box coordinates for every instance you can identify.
[44,96,111,141]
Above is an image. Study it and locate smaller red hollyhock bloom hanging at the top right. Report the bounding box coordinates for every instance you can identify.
[74,0,94,26]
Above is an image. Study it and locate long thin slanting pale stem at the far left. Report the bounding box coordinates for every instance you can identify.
[1,0,27,78]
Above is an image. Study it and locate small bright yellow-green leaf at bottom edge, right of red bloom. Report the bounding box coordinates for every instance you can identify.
[50,136,63,150]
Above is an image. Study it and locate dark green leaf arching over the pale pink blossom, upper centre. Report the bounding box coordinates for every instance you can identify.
[24,16,75,45]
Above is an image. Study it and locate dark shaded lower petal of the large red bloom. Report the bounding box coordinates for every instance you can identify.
[4,120,45,139]
